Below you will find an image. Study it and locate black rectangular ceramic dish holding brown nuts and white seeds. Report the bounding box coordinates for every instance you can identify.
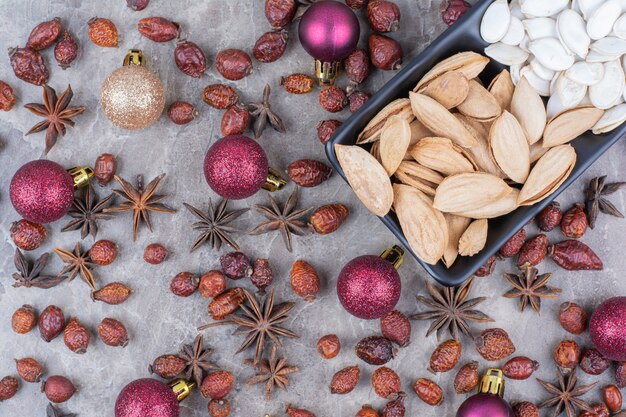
[326,0,626,286]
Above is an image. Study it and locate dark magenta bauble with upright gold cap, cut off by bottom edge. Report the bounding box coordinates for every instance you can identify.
[456,369,514,417]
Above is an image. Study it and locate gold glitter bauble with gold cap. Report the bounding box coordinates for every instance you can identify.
[100,49,165,130]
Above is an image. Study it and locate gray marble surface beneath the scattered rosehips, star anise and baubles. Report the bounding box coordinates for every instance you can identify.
[0,0,626,417]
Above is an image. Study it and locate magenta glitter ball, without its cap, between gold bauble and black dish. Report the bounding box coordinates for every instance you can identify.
[204,135,269,200]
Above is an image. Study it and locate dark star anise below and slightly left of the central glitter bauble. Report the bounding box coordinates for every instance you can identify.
[183,200,250,252]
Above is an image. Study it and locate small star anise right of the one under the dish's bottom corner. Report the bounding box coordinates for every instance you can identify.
[504,267,561,314]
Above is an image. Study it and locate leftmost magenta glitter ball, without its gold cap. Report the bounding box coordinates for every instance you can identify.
[9,159,74,223]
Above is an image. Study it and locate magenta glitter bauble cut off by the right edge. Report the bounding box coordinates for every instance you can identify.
[589,297,626,362]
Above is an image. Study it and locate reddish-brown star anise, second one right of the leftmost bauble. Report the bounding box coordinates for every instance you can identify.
[104,174,176,240]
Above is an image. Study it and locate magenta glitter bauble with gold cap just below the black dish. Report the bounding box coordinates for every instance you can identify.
[337,246,404,320]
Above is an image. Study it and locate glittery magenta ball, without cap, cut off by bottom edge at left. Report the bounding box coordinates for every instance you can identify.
[115,378,180,417]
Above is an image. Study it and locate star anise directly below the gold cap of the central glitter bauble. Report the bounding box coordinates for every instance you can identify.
[249,187,313,252]
